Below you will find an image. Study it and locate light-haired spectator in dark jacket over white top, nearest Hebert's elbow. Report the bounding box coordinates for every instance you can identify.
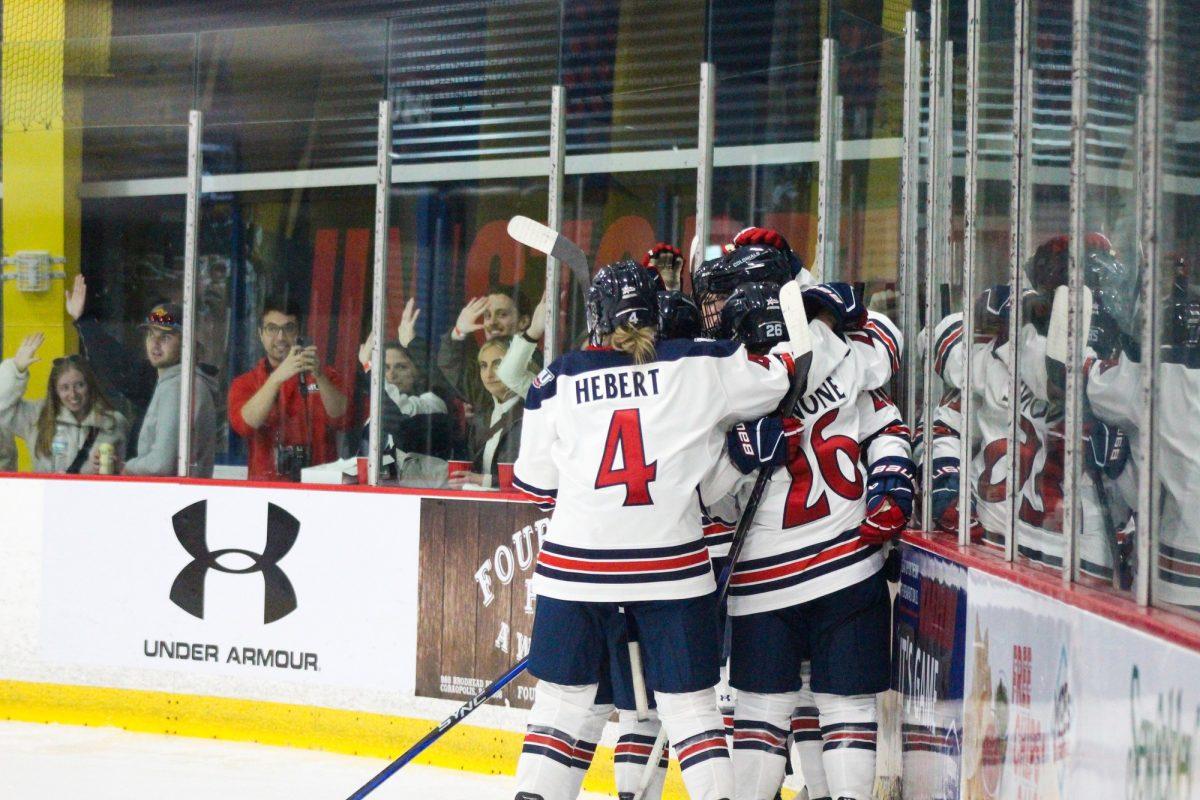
[450,337,524,489]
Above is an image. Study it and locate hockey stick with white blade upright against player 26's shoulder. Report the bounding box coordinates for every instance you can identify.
[634,281,812,800]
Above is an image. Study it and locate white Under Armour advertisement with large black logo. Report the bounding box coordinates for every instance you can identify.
[40,481,420,692]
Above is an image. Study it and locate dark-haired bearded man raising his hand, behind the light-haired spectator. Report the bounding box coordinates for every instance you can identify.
[438,285,540,409]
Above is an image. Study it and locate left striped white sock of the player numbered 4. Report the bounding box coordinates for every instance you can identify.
[517,680,612,800]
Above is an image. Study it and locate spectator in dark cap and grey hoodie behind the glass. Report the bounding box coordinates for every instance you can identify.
[91,303,218,477]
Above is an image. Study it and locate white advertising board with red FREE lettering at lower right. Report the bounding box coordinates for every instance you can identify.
[961,570,1200,800]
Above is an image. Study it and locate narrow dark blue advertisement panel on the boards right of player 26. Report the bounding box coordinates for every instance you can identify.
[893,547,967,800]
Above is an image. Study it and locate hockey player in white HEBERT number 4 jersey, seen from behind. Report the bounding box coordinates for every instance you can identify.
[514,261,790,800]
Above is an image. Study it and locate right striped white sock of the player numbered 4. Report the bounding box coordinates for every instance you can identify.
[654,688,733,800]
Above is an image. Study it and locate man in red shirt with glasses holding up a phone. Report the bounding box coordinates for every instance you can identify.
[229,300,350,481]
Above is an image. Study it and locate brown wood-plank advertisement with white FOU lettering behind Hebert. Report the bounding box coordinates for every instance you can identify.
[416,498,550,708]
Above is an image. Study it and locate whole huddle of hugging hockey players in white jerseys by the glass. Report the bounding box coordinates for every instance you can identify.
[514,228,916,800]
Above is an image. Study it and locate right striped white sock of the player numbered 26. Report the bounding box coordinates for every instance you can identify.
[812,692,877,800]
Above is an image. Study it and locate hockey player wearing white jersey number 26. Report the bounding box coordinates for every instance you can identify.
[705,278,913,800]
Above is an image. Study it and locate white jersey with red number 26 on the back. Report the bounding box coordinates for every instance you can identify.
[730,323,900,615]
